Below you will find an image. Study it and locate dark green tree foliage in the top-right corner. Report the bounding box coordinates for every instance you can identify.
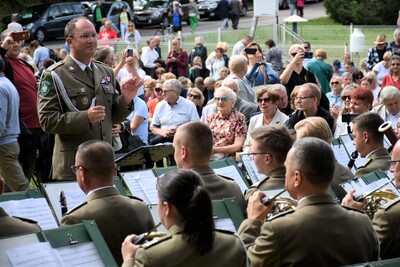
[324,0,400,25]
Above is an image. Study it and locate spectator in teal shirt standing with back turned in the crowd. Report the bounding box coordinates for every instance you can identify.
[307,49,332,94]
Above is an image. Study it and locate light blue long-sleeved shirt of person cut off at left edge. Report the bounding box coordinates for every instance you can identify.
[0,73,20,145]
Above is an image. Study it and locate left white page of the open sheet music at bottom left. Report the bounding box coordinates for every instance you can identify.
[6,242,67,267]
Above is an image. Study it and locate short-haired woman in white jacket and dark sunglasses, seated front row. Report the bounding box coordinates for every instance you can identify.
[243,85,289,152]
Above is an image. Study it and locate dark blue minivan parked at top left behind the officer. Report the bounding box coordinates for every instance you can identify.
[3,2,86,42]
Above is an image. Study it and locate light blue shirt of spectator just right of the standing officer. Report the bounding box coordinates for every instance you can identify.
[127,96,149,145]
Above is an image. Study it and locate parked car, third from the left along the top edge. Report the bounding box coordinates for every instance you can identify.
[135,0,190,27]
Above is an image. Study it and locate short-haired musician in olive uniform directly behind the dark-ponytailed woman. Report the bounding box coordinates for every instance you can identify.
[173,122,246,217]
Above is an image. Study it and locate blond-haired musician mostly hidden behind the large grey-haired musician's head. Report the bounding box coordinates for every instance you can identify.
[294,117,354,201]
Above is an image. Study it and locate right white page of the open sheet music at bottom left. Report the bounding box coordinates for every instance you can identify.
[54,242,105,267]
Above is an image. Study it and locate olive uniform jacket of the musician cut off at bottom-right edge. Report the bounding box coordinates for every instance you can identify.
[372,198,400,259]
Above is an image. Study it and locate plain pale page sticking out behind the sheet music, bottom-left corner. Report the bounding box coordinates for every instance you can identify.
[0,234,40,267]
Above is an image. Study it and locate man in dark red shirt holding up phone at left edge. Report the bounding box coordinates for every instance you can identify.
[0,30,41,183]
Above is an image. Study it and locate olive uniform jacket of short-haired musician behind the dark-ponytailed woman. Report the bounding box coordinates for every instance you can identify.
[192,166,247,217]
